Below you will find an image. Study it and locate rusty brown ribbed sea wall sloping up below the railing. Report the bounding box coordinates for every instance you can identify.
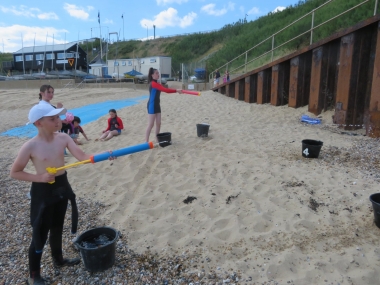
[212,15,380,137]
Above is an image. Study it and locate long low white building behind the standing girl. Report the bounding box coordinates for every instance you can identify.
[107,56,172,78]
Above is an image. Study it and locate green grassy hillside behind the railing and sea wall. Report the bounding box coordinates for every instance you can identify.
[84,0,375,73]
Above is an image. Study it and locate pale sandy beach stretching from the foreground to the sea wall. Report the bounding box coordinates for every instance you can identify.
[0,85,380,285]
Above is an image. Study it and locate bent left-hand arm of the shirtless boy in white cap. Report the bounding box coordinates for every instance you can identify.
[10,143,54,182]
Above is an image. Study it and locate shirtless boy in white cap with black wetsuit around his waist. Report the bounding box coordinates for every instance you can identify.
[10,104,113,285]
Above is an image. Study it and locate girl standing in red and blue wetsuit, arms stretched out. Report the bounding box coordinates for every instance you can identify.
[145,67,182,142]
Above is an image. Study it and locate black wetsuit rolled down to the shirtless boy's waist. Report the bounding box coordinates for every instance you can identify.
[29,172,78,272]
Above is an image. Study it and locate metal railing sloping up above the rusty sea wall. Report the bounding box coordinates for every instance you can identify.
[209,0,378,82]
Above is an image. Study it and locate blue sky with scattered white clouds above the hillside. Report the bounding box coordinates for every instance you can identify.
[0,0,298,52]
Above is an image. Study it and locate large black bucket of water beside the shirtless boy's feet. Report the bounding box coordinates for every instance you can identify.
[74,227,119,272]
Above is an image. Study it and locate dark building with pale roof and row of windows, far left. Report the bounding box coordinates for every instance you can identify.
[11,42,88,73]
